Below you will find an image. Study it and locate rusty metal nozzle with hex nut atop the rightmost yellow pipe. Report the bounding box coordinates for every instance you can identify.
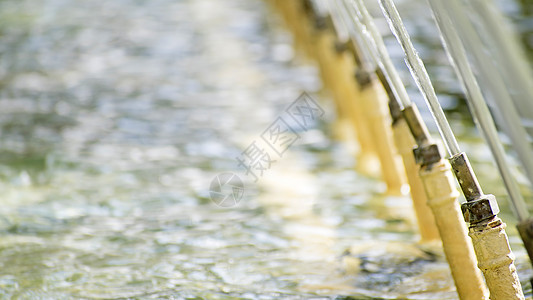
[450,152,500,224]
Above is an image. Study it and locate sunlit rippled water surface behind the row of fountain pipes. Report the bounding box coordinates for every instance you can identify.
[0,0,532,299]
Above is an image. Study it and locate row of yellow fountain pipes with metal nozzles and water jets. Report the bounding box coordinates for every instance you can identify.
[271,0,533,300]
